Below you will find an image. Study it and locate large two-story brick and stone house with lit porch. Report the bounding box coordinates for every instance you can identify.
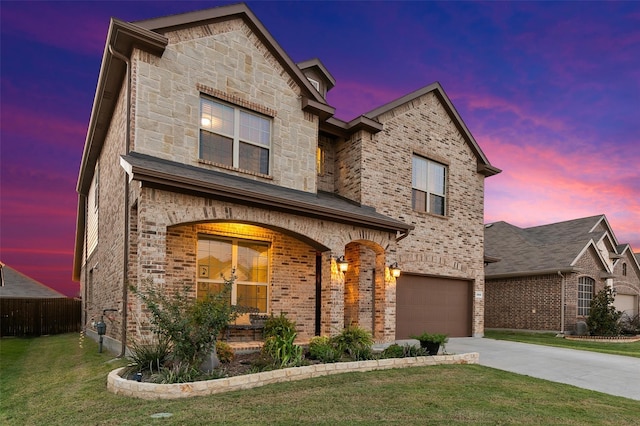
[74,4,500,350]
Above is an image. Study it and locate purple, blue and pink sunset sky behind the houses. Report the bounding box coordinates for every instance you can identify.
[0,0,640,295]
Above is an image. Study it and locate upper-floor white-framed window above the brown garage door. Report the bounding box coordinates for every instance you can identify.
[411,155,447,216]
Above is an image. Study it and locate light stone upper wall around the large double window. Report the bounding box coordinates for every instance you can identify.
[134,19,318,192]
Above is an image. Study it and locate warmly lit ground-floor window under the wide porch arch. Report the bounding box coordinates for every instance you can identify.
[197,237,269,313]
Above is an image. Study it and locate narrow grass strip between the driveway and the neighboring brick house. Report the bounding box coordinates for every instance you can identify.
[484,330,640,358]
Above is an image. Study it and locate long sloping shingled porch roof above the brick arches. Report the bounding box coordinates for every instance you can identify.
[121,152,414,233]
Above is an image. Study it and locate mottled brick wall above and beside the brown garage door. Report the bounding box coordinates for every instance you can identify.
[358,93,484,336]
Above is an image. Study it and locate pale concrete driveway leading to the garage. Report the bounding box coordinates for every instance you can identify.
[446,337,640,401]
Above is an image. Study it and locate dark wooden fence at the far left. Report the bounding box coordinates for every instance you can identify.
[0,298,82,337]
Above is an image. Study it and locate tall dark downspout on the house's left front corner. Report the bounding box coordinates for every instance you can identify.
[108,45,131,358]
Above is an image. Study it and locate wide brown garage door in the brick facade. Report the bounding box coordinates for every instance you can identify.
[396,274,472,339]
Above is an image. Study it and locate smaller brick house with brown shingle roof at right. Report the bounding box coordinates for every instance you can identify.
[485,215,640,333]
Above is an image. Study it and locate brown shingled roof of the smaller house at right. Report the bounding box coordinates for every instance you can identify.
[484,215,616,278]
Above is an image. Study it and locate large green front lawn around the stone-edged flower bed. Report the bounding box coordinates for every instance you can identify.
[0,334,640,425]
